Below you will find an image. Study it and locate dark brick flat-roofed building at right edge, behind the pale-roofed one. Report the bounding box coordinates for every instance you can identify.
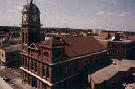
[108,33,135,59]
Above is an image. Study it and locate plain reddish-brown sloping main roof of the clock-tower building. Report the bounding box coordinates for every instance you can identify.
[63,37,107,57]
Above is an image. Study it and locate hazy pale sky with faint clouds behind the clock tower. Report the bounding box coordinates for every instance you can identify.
[0,0,135,31]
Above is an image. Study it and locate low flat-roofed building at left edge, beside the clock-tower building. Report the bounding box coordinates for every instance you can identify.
[0,44,21,68]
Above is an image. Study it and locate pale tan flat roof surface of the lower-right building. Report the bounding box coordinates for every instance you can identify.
[88,59,135,84]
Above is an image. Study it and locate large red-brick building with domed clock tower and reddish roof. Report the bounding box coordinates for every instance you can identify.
[20,0,108,89]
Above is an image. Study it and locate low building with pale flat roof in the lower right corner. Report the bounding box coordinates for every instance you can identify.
[88,60,135,89]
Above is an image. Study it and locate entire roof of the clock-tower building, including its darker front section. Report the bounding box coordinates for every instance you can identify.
[40,36,107,57]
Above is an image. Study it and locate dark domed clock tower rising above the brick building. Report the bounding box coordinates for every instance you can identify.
[22,0,41,46]
